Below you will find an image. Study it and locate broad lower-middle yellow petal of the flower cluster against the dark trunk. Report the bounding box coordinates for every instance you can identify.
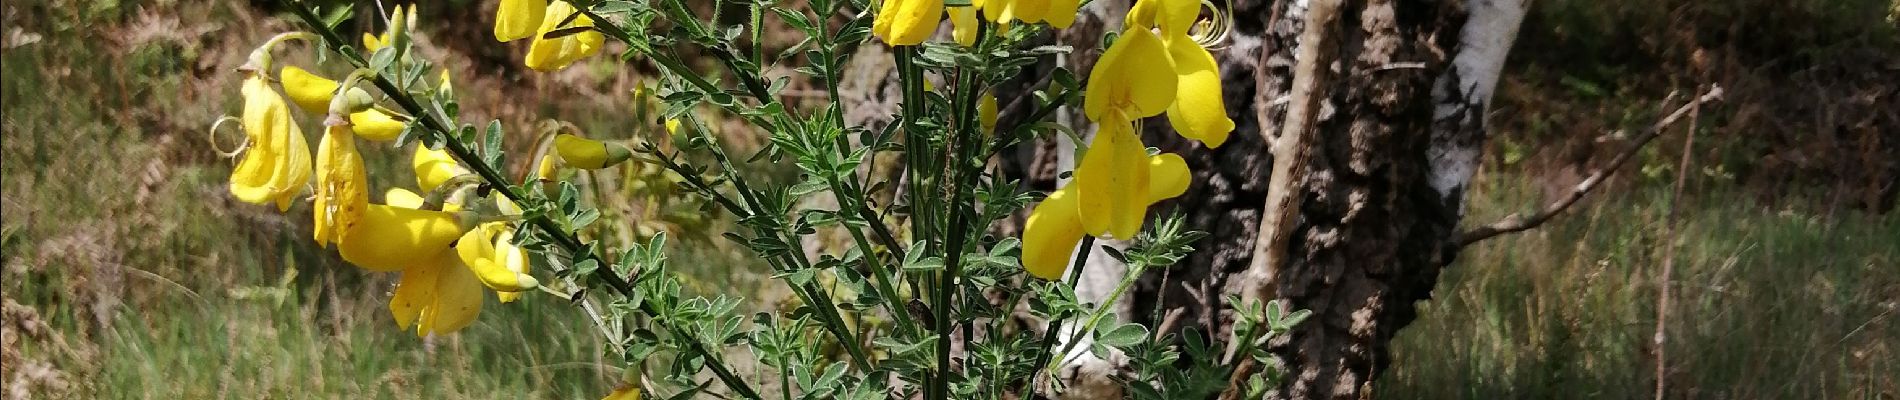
[1075,114,1148,239]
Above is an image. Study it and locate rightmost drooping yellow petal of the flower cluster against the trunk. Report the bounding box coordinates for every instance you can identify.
[1167,34,1233,148]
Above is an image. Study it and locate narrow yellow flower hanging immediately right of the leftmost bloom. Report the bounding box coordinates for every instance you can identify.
[312,125,369,246]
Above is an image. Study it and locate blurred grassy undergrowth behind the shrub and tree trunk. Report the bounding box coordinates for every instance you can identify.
[0,0,1900,398]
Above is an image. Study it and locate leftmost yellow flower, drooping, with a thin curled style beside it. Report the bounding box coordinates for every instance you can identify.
[230,74,310,210]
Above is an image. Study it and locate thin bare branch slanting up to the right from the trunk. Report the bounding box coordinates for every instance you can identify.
[1457,85,1721,246]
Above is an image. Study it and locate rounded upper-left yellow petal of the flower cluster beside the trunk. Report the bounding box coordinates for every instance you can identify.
[1083,28,1176,121]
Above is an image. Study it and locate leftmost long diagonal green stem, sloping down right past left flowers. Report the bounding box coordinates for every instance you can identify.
[291,2,760,398]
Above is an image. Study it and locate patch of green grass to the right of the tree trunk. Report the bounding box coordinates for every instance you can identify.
[1376,170,1900,398]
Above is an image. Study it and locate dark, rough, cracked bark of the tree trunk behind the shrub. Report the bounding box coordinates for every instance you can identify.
[1136,0,1482,398]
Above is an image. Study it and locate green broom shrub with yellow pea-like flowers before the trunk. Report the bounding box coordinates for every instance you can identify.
[213,0,1303,398]
